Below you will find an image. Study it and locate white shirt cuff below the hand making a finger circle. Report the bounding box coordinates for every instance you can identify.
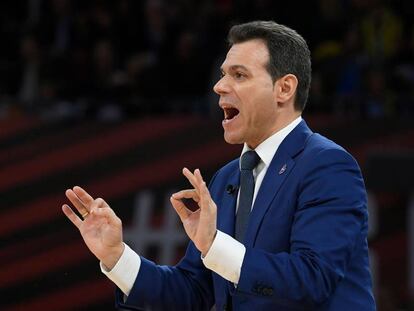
[202,230,246,284]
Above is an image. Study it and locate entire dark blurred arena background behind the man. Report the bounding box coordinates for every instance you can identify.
[0,0,414,310]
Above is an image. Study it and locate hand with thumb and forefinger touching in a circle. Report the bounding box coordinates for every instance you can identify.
[170,168,217,256]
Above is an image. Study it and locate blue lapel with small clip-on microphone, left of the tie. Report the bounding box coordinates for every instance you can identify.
[217,166,240,236]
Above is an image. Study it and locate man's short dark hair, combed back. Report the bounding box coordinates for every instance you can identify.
[228,21,312,111]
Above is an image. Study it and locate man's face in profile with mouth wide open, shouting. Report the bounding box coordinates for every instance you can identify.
[214,40,277,148]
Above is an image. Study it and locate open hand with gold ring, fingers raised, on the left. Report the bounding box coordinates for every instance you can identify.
[62,186,124,270]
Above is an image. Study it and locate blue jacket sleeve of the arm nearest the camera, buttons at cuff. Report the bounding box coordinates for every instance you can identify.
[233,149,367,309]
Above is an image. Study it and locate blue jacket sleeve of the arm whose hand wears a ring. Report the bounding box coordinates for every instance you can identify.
[116,174,217,311]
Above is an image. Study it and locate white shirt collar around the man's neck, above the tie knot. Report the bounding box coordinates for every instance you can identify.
[239,116,302,166]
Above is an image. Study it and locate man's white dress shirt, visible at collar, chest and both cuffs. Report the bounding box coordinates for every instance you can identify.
[100,116,302,296]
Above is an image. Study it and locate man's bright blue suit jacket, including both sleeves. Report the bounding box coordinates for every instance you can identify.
[117,121,375,311]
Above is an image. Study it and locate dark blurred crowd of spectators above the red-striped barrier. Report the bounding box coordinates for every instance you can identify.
[0,0,414,120]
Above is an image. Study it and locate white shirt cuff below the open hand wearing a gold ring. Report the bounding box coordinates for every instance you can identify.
[99,243,141,296]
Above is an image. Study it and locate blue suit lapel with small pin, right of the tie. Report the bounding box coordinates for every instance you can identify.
[244,121,312,247]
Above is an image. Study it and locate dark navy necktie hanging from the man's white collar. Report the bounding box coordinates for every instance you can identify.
[235,150,260,242]
